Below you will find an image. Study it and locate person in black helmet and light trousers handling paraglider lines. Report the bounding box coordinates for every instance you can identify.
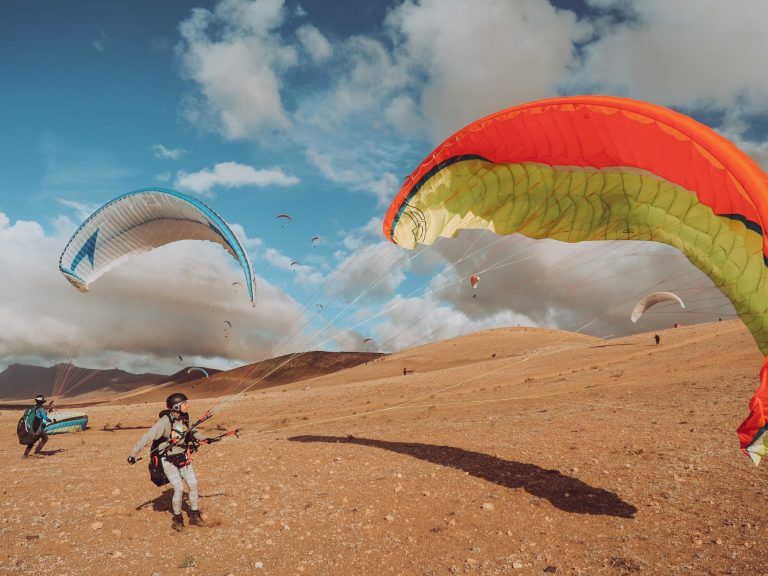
[128,392,208,531]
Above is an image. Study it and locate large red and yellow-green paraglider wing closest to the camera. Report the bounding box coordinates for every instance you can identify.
[383,96,768,463]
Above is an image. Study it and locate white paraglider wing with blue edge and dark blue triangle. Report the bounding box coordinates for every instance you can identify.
[59,188,255,302]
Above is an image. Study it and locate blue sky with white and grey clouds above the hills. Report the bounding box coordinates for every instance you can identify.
[0,0,768,371]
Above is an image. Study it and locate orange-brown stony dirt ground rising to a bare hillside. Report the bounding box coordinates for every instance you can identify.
[0,321,768,576]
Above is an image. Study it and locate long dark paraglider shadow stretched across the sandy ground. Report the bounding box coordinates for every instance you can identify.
[289,436,637,518]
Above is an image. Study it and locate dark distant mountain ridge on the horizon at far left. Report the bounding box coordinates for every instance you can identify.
[0,364,168,400]
